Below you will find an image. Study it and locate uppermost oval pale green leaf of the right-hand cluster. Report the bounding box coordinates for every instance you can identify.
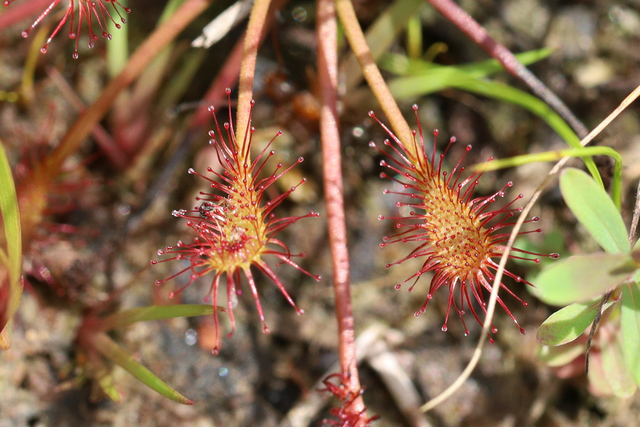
[560,168,630,254]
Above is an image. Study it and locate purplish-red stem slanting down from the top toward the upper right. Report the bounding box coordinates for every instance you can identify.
[427,0,589,138]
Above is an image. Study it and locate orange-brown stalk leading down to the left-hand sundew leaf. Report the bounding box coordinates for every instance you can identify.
[236,0,271,149]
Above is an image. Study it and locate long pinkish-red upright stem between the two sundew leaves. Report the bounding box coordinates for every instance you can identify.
[317,0,364,422]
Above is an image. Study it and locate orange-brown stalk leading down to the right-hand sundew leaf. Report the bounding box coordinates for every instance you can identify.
[335,0,418,156]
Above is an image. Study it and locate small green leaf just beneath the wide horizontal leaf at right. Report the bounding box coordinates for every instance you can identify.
[537,298,613,346]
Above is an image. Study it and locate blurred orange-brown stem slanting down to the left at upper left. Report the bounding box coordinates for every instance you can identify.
[42,0,212,177]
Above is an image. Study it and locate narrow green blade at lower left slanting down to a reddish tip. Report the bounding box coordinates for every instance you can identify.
[93,333,193,405]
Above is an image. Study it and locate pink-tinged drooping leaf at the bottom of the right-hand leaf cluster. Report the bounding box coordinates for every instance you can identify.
[600,322,637,397]
